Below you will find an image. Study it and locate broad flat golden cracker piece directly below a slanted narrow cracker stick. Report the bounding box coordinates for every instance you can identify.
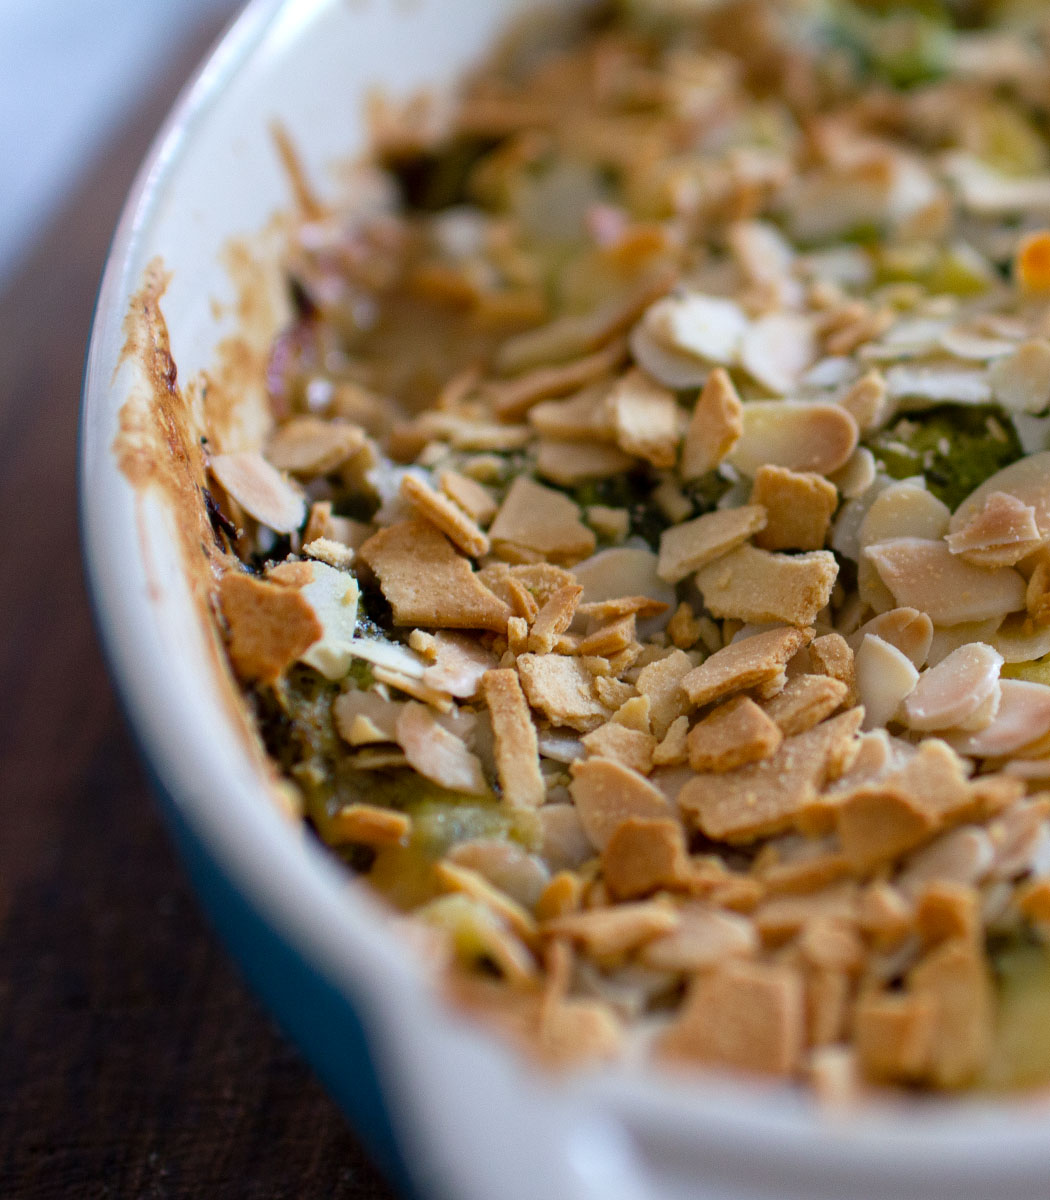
[358,521,511,634]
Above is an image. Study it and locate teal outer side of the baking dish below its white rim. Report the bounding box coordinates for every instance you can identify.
[146,763,420,1200]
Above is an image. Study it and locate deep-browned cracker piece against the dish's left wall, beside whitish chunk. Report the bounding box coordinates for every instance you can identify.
[218,570,324,683]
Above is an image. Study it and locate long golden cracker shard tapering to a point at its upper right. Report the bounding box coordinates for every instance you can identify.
[678,708,864,842]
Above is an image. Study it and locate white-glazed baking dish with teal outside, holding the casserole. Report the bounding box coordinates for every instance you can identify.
[80,0,1050,1200]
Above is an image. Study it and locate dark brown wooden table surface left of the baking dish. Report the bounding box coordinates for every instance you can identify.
[0,18,392,1200]
